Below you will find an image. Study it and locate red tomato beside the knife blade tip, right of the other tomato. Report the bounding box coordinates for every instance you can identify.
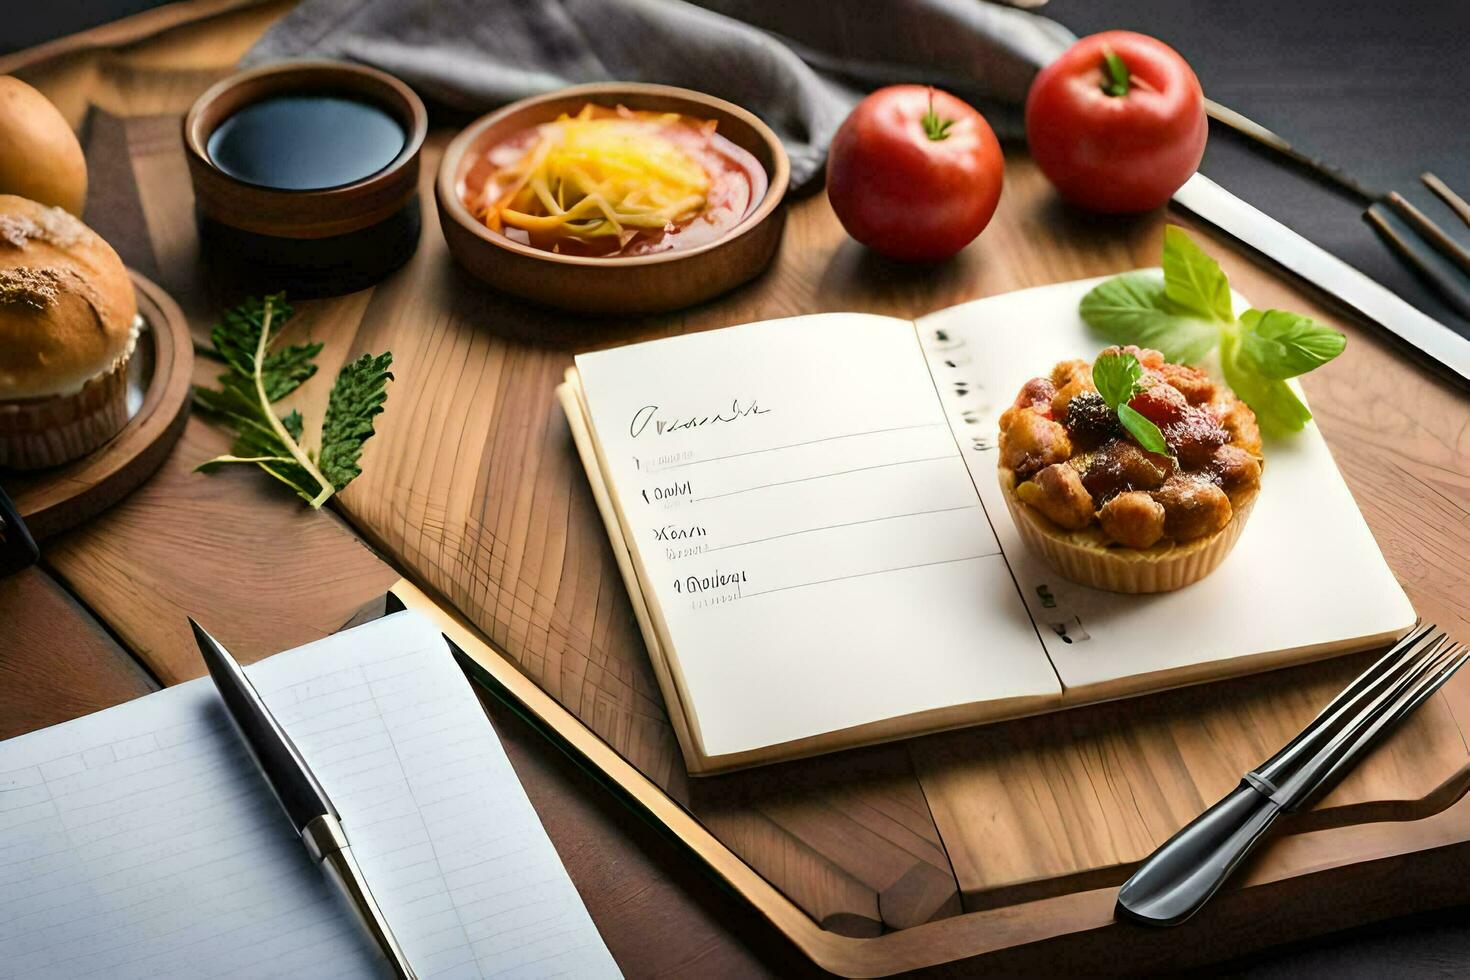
[1026,31,1210,215]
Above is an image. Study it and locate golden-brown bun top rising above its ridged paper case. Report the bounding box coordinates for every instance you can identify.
[0,194,138,401]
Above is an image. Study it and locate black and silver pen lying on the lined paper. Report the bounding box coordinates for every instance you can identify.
[188,619,415,980]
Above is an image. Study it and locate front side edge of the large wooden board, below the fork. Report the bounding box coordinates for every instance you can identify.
[414,582,1470,977]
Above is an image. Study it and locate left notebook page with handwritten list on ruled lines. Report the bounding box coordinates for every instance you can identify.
[576,314,1060,755]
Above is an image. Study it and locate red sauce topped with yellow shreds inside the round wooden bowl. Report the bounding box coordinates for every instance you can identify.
[459,104,769,257]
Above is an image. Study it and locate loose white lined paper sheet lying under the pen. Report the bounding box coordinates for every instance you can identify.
[0,613,617,979]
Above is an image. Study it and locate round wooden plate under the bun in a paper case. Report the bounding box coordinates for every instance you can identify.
[0,269,194,541]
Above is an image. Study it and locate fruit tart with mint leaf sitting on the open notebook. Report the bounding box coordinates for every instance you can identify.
[1000,347,1263,592]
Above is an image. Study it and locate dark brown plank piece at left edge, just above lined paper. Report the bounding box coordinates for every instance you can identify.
[0,567,156,739]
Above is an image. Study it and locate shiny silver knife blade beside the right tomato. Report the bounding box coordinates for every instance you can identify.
[1175,173,1470,381]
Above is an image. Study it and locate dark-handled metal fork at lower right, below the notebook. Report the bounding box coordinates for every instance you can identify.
[1114,624,1470,926]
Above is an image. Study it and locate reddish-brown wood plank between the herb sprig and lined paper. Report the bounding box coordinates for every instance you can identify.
[46,417,397,685]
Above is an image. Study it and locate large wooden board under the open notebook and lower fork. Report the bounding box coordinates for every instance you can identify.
[111,118,1470,976]
